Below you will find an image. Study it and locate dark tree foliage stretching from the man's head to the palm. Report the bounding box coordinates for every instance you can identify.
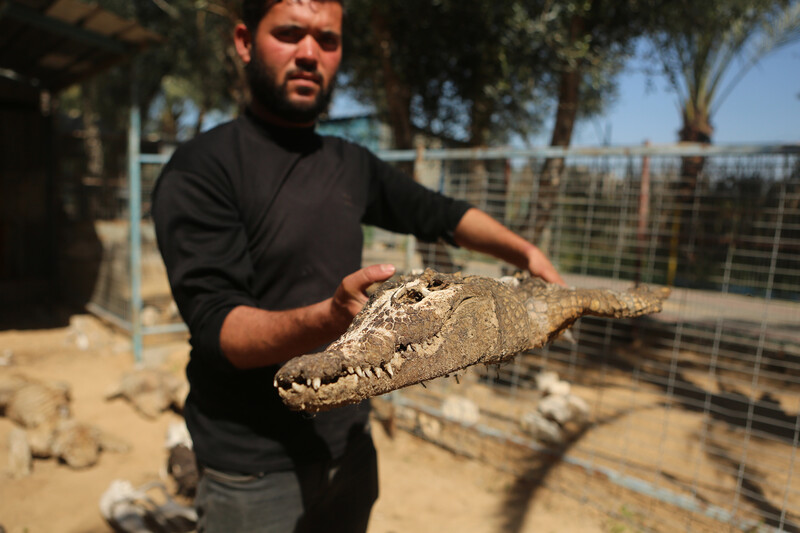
[344,0,660,148]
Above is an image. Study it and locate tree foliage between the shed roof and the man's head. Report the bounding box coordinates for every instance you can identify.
[63,0,244,141]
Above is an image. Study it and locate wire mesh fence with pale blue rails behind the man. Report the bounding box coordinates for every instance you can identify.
[93,142,800,531]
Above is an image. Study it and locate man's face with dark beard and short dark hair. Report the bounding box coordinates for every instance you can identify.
[246,0,342,124]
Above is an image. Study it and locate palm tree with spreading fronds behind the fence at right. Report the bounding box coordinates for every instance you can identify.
[652,0,800,285]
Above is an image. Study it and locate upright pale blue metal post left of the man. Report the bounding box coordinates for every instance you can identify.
[128,61,142,364]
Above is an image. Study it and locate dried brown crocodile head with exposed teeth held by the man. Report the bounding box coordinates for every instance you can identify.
[275,270,669,412]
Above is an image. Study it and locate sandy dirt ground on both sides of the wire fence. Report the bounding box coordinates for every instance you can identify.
[0,315,800,533]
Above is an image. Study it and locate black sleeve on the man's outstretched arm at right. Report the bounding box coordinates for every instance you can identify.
[363,153,471,246]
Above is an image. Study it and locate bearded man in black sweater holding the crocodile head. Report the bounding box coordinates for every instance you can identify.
[153,0,563,532]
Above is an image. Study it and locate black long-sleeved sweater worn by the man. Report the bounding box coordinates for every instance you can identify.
[153,114,469,474]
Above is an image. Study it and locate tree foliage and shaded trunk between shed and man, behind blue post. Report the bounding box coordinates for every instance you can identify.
[52,0,244,222]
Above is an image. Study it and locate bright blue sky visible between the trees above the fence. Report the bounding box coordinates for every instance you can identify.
[331,43,800,146]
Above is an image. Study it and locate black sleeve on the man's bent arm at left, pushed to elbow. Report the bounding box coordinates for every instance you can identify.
[153,160,257,371]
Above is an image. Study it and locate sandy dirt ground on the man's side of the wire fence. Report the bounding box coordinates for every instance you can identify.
[0,315,630,533]
